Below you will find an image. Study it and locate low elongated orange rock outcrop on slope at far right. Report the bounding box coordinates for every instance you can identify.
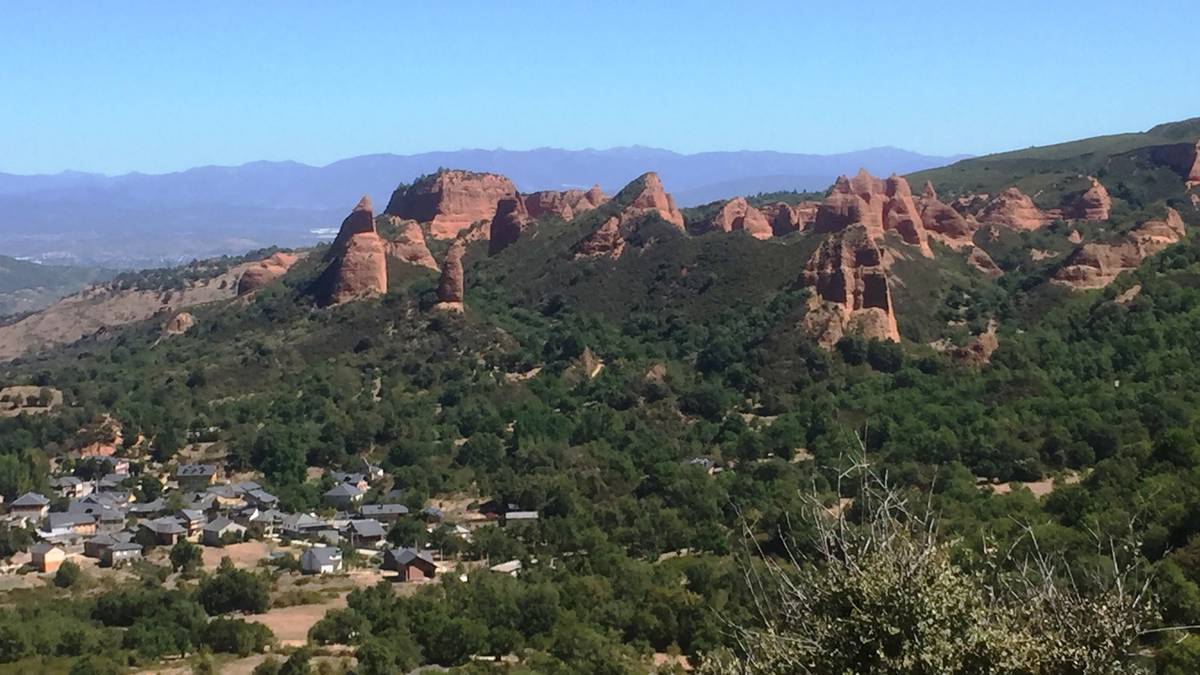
[1054,208,1184,289]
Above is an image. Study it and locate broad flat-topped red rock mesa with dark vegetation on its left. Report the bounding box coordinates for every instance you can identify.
[385,169,517,239]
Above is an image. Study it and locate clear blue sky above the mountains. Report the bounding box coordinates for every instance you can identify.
[0,0,1200,173]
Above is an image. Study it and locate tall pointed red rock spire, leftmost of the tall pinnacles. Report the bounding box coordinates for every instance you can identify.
[317,196,388,305]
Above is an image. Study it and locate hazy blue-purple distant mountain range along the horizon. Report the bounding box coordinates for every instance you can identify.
[0,147,964,267]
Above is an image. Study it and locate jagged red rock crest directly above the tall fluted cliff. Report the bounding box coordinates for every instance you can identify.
[814,169,932,257]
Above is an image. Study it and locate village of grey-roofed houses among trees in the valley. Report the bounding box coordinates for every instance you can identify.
[0,425,539,583]
